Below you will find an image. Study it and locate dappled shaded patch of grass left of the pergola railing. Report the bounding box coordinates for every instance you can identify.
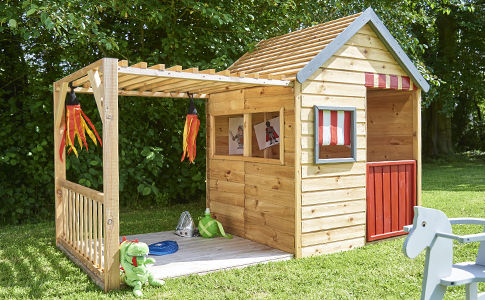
[0,223,97,298]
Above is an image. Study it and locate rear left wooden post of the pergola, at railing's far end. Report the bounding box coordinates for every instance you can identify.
[52,83,67,244]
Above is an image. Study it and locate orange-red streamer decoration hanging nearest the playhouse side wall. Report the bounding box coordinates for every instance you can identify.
[181,93,200,163]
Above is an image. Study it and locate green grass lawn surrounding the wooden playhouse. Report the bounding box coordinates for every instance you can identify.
[0,161,485,299]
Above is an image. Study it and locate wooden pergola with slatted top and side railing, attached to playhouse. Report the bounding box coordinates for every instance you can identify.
[53,58,293,291]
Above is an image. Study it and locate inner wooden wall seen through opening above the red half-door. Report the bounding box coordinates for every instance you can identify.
[367,89,414,162]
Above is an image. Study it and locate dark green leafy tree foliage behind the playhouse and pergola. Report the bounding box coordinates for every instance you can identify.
[0,0,485,223]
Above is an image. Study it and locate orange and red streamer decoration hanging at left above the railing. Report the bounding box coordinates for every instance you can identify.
[59,82,103,161]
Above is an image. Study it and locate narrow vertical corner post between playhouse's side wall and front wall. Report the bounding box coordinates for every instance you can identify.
[294,81,302,258]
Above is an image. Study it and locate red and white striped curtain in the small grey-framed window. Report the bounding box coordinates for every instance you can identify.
[318,110,351,146]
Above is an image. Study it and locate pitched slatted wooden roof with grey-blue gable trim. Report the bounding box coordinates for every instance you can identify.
[228,7,429,92]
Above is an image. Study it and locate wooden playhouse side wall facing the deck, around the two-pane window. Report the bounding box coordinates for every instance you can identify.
[207,87,295,253]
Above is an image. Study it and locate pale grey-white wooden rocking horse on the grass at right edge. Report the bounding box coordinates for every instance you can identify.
[403,206,485,300]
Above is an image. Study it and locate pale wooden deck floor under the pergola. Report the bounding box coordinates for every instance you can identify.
[126,231,293,278]
